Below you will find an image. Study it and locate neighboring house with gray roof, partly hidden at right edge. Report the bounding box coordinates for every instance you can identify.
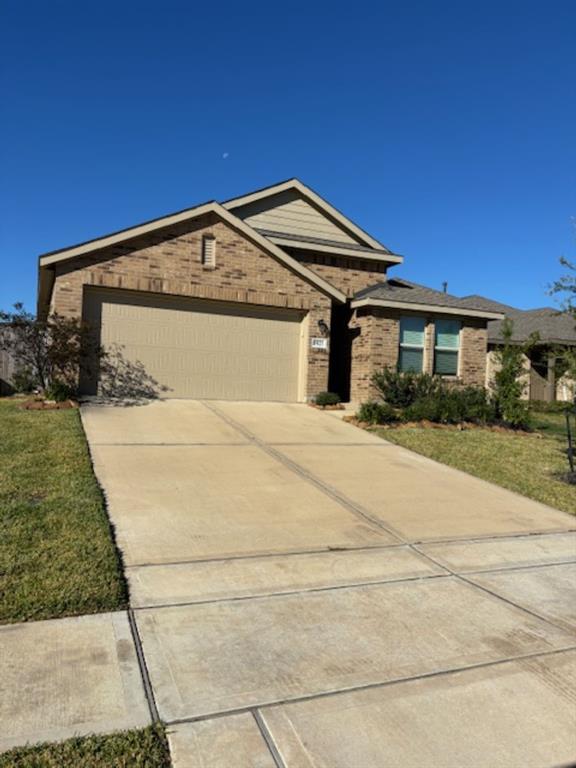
[462,296,576,402]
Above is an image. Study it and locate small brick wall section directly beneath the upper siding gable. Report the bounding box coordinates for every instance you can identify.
[293,251,386,298]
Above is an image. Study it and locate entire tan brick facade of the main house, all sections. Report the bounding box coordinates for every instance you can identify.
[44,214,487,402]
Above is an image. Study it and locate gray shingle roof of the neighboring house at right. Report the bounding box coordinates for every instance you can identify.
[462,296,576,344]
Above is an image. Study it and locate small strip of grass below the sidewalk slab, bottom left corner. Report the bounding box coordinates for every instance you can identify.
[0,725,171,768]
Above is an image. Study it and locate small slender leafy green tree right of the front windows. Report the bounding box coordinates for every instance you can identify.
[492,317,537,429]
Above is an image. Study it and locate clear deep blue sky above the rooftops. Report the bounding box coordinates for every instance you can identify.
[0,0,576,308]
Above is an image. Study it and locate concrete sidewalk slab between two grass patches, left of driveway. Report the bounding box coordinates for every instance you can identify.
[0,611,151,751]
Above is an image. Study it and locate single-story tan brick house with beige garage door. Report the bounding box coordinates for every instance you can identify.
[38,179,502,401]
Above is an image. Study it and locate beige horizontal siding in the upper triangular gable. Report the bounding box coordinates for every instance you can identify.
[233,191,360,244]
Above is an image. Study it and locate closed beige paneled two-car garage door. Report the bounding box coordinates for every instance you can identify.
[83,289,304,401]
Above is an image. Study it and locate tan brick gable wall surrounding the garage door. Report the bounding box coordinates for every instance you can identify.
[51,214,331,397]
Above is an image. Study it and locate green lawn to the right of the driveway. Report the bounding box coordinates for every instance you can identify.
[375,413,576,514]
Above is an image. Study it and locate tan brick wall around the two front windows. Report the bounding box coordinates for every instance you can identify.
[350,308,487,402]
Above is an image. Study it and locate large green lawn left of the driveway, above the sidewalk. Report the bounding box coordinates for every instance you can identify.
[0,398,127,623]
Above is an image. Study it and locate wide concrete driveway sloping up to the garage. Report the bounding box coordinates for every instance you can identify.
[82,400,576,768]
